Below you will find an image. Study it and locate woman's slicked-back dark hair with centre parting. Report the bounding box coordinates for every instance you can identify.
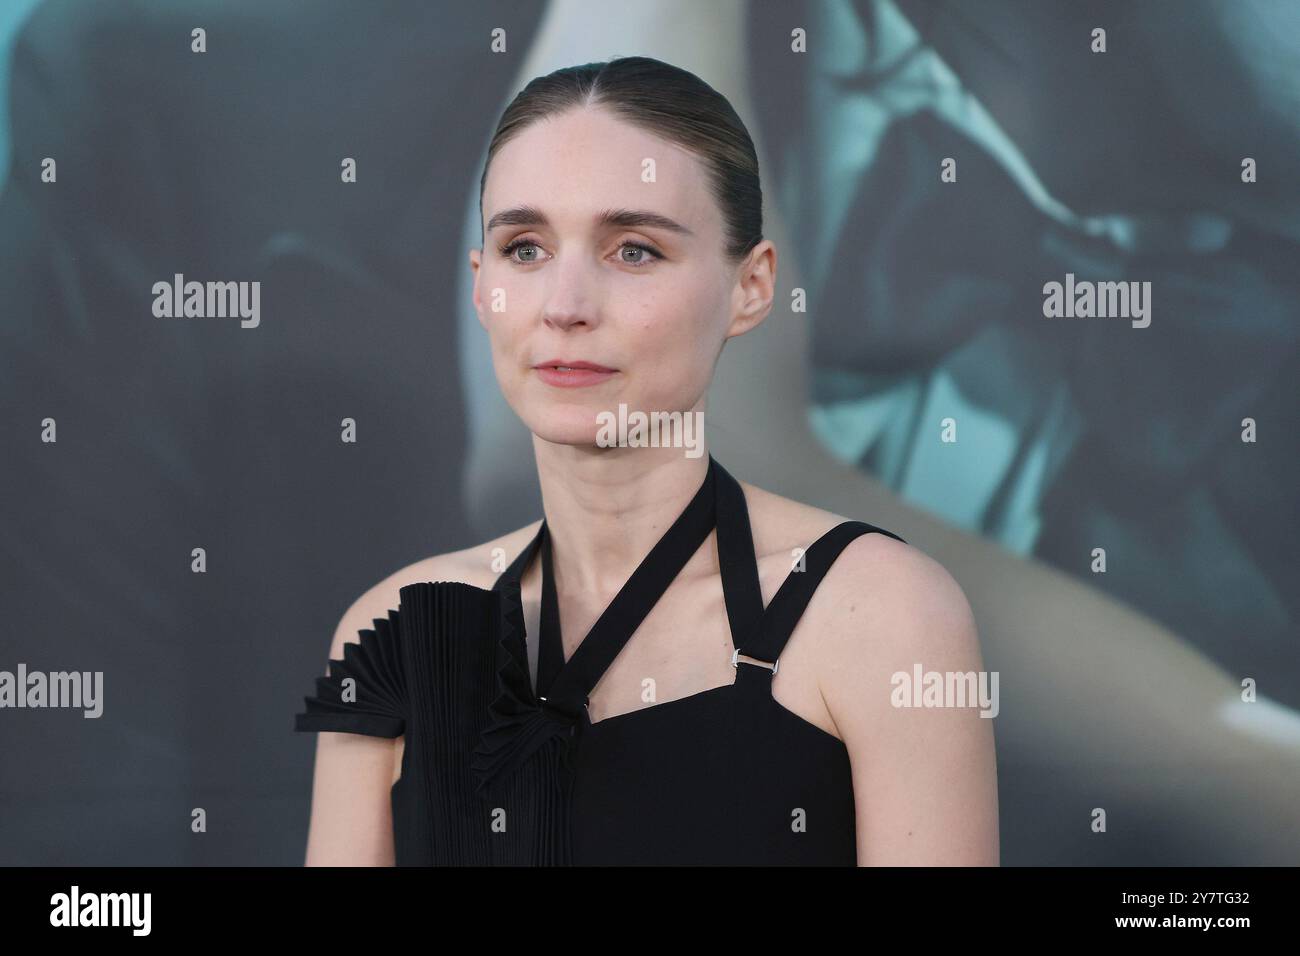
[478,56,763,263]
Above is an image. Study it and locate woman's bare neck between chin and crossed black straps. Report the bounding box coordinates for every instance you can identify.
[533,436,709,598]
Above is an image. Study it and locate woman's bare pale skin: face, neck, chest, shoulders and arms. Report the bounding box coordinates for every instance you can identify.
[307,98,998,865]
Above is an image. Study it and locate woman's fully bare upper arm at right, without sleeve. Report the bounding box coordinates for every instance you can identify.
[819,535,998,866]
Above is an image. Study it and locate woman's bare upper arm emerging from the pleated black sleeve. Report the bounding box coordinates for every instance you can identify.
[306,583,404,866]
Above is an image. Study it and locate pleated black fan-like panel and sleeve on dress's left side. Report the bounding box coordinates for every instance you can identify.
[295,576,572,866]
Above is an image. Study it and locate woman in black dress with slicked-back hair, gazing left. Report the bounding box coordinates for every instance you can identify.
[298,57,997,865]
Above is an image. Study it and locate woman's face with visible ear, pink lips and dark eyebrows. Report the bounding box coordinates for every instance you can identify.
[469,108,775,445]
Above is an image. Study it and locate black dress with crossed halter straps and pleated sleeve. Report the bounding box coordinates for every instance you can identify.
[295,457,902,866]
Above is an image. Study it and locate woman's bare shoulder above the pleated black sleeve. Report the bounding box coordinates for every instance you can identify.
[330,519,541,659]
